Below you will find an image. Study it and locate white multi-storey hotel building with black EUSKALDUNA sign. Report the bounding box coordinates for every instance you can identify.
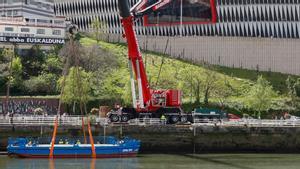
[0,0,67,45]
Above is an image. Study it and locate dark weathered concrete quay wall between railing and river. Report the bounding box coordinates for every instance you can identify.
[0,125,300,153]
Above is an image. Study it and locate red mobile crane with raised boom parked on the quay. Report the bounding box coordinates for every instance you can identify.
[108,0,187,123]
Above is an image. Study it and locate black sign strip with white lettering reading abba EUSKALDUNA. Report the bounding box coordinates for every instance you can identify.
[0,36,65,45]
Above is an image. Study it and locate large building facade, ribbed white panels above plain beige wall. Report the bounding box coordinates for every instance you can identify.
[54,0,300,75]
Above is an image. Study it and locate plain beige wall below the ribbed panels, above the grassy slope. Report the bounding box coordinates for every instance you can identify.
[106,34,300,75]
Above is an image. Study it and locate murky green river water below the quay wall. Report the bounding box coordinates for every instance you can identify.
[0,154,300,169]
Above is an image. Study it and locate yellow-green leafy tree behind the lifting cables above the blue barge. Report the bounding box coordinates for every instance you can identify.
[59,67,92,113]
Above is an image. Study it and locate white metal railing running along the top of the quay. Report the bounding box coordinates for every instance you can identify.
[0,115,300,127]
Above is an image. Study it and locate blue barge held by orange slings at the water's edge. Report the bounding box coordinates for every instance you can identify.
[7,137,140,158]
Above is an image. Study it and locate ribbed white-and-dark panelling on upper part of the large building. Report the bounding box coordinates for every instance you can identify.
[54,0,300,39]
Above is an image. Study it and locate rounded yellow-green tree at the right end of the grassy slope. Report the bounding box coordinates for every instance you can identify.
[246,76,277,118]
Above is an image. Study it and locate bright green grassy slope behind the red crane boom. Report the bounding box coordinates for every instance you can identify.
[81,38,294,112]
